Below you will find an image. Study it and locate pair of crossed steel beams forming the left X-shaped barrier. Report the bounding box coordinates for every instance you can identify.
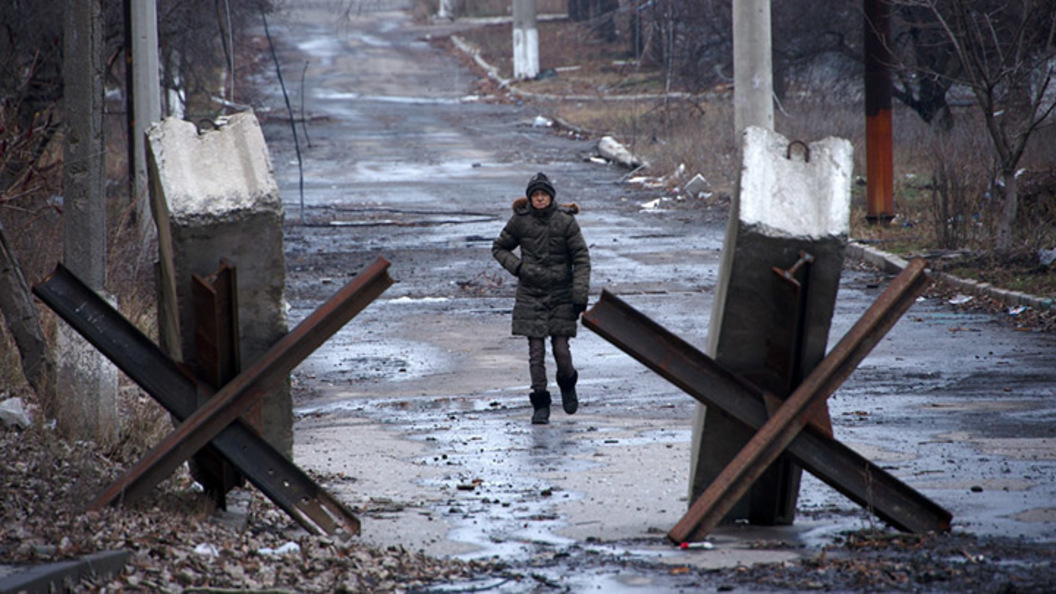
[33,258,393,536]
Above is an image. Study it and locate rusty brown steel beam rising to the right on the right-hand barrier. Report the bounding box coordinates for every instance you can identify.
[667,258,930,542]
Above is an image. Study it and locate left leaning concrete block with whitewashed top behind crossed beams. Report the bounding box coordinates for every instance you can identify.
[147,112,294,458]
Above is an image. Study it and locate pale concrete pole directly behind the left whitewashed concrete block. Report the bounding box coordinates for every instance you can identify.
[126,0,162,243]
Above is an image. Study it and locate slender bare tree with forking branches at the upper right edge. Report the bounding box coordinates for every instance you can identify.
[907,0,1056,252]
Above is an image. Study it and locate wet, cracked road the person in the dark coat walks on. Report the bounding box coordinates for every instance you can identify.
[260,0,1056,592]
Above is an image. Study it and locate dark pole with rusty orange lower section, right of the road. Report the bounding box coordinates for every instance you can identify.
[864,0,894,224]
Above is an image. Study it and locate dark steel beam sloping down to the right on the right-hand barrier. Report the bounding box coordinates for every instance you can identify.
[583,256,951,534]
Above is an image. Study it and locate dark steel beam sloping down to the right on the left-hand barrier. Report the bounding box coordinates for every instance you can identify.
[33,264,371,536]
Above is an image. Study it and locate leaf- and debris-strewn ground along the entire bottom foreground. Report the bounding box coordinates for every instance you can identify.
[0,418,1056,592]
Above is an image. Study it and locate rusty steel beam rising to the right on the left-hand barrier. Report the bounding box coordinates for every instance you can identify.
[90,258,393,508]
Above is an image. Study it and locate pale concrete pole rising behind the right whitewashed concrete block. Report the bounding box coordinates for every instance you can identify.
[733,0,774,135]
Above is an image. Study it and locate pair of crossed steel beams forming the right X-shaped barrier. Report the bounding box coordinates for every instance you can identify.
[583,259,953,543]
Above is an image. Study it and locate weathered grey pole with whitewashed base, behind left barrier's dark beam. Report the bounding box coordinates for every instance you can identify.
[56,0,118,443]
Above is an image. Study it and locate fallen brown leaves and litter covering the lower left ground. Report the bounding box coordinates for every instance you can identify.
[0,426,509,592]
